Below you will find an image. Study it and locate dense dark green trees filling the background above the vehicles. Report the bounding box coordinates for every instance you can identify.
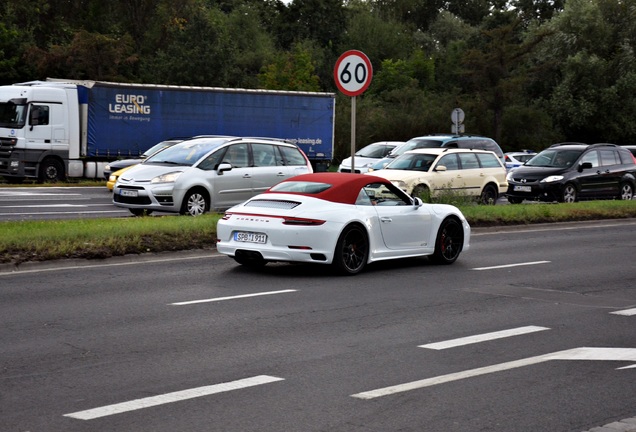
[0,0,636,163]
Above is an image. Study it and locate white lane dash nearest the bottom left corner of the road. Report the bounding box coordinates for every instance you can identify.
[64,375,284,420]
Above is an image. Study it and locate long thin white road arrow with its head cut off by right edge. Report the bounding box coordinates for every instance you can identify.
[351,347,636,399]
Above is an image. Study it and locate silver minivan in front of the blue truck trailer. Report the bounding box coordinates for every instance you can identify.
[113,137,313,216]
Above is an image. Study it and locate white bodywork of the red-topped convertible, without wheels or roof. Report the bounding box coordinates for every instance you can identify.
[217,193,470,264]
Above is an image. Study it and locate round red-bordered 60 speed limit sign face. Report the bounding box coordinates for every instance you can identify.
[333,50,373,96]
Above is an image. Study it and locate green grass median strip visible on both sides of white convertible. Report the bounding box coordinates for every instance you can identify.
[0,201,636,264]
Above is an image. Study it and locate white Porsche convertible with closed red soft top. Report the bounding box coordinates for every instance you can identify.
[216,173,470,275]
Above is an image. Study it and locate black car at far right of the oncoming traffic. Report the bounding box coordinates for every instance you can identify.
[507,143,636,204]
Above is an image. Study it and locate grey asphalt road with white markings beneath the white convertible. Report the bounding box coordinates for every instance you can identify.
[0,221,636,432]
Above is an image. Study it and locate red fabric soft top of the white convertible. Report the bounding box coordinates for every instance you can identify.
[265,172,391,204]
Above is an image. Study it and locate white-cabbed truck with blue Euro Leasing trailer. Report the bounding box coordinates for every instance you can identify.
[0,79,335,183]
